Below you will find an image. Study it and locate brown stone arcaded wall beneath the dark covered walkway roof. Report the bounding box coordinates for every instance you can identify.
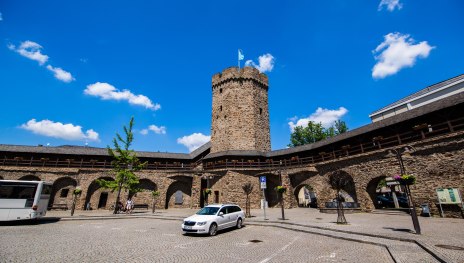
[0,132,464,217]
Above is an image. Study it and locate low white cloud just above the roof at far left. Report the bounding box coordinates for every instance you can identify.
[21,119,100,141]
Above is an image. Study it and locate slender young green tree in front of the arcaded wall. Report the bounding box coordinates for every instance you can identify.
[97,117,146,214]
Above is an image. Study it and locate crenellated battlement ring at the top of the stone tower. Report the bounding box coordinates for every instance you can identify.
[212,67,269,88]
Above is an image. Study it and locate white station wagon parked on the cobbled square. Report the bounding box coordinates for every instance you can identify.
[182,204,245,236]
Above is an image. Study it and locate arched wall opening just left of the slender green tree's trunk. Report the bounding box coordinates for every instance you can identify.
[83,177,115,209]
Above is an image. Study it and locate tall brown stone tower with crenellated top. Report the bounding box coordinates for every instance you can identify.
[211,67,271,153]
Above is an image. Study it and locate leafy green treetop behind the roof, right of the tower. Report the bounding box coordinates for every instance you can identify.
[288,120,348,147]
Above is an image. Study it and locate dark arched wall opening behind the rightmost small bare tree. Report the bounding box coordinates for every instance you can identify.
[329,170,358,206]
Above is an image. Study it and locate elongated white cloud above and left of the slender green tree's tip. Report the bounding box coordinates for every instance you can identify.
[84,82,161,111]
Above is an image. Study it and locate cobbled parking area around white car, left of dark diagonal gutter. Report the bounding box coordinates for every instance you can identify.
[0,218,393,263]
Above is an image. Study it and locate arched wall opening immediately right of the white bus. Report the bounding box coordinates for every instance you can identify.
[48,177,77,207]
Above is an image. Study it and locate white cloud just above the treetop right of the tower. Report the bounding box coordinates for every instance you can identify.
[288,107,348,132]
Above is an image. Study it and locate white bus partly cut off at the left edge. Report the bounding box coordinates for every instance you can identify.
[0,180,52,221]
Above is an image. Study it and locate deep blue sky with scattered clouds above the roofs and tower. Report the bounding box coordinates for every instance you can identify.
[0,0,464,152]
